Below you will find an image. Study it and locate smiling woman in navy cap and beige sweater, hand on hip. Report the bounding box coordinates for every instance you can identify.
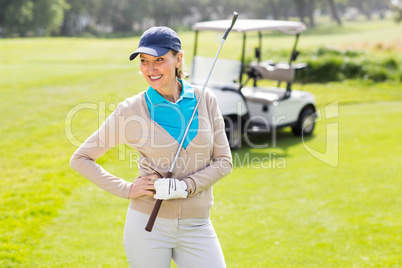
[70,27,232,268]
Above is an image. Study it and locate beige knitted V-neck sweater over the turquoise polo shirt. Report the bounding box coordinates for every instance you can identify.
[70,86,232,219]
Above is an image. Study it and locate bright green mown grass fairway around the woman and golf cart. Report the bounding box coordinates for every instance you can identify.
[0,18,402,267]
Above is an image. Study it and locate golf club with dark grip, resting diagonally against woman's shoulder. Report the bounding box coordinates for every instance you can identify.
[145,12,239,232]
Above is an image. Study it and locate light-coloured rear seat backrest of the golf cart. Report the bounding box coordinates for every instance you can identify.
[249,61,307,83]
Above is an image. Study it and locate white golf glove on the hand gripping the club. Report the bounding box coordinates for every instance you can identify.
[154,178,188,200]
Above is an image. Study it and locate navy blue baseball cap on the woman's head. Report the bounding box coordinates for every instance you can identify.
[130,26,181,60]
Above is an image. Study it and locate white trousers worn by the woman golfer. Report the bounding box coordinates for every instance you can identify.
[123,208,226,268]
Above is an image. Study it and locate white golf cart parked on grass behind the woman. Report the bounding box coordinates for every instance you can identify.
[190,19,316,149]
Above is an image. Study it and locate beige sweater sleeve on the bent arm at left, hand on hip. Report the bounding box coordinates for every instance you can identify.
[70,101,132,198]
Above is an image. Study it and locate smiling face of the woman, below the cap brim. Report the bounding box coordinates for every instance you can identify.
[140,51,183,92]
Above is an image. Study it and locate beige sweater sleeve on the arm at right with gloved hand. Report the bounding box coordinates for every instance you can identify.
[184,91,233,196]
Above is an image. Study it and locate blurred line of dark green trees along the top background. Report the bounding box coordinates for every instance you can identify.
[0,0,391,37]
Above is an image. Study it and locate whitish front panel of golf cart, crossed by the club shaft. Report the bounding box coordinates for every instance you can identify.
[190,56,241,88]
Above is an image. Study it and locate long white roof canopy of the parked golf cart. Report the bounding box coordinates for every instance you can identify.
[193,19,307,34]
